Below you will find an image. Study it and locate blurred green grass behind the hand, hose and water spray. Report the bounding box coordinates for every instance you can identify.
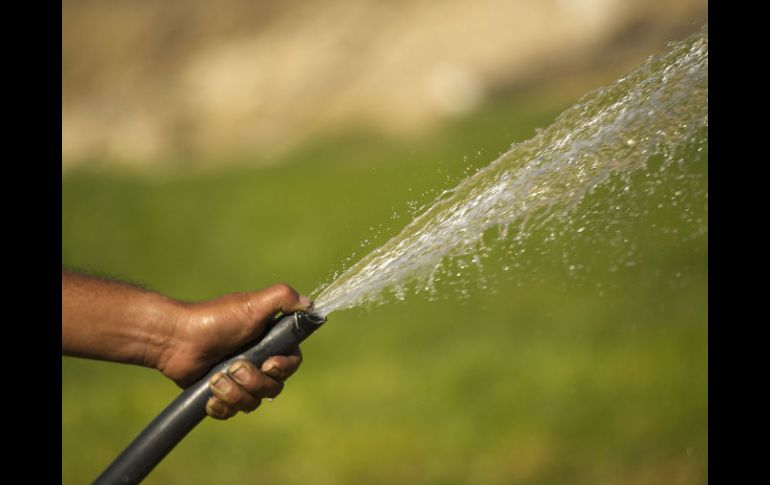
[62,85,708,484]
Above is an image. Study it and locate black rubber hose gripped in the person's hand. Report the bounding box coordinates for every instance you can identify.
[94,312,326,485]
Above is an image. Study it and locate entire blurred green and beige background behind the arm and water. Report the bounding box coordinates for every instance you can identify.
[62,0,708,485]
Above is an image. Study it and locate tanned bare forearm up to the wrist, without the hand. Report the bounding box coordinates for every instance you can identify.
[62,270,182,367]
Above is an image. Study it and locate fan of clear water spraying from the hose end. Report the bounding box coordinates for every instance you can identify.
[316,25,708,315]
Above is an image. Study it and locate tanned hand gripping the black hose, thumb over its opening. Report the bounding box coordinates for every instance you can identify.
[157,284,313,419]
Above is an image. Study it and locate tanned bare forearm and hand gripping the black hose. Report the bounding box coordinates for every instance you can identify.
[62,269,313,419]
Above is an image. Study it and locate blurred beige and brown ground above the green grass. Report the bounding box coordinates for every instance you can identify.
[62,0,707,170]
